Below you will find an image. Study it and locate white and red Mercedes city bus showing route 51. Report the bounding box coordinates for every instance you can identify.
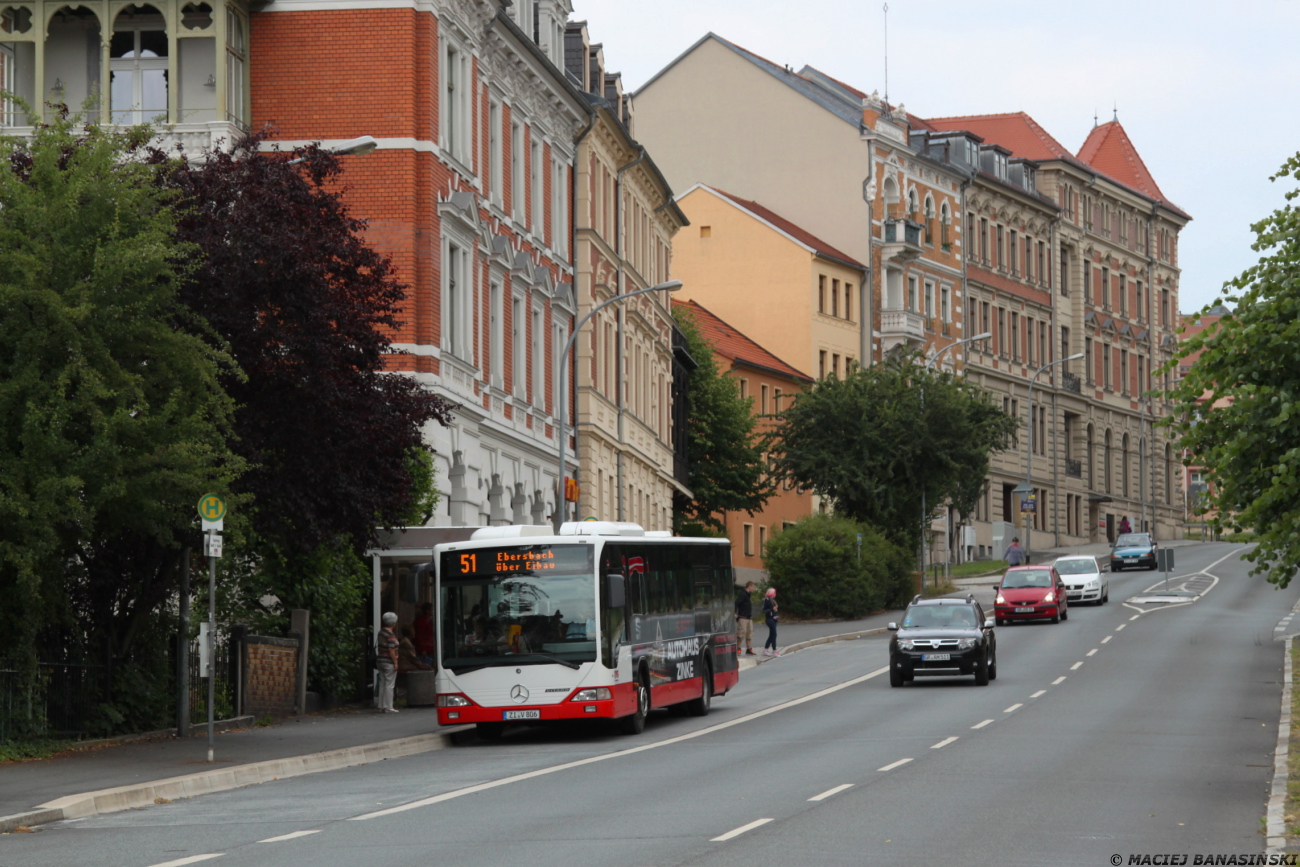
[434,521,740,737]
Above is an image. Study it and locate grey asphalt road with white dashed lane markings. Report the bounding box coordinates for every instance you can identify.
[0,545,1300,867]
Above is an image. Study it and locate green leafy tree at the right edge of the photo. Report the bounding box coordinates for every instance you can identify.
[1161,153,1300,588]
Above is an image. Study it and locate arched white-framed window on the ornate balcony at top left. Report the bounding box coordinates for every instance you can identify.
[108,5,167,123]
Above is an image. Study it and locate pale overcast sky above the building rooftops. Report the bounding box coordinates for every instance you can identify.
[573,0,1300,312]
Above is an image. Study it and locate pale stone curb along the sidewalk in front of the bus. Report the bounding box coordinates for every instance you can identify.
[0,725,472,833]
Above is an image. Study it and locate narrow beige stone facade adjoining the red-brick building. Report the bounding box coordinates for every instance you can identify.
[567,22,690,530]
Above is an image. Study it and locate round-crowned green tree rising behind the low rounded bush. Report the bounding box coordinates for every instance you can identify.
[771,355,1017,550]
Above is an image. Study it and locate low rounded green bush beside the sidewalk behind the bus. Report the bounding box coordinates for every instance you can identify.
[763,515,914,619]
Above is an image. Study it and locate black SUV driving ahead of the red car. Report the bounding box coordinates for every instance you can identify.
[889,595,997,686]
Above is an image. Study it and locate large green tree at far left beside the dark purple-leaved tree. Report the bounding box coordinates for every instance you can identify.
[0,113,241,727]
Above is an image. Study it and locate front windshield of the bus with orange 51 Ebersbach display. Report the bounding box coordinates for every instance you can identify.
[438,545,597,673]
